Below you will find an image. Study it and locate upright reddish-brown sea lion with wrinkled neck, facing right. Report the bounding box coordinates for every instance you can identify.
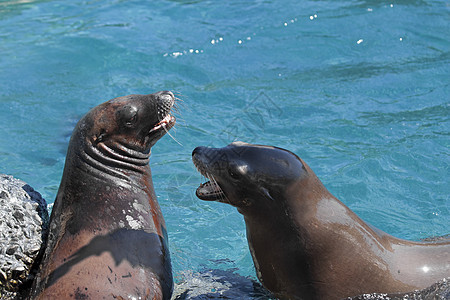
[30,91,175,299]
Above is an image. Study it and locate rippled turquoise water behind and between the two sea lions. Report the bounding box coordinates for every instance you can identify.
[0,0,450,292]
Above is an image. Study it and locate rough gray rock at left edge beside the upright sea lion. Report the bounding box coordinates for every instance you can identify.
[0,174,49,299]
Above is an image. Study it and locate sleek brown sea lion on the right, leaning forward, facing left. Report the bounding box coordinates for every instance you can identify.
[192,142,450,299]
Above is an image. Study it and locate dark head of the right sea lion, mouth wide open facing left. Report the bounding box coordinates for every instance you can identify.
[192,142,307,212]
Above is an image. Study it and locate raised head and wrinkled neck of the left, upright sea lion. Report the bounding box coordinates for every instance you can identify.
[67,91,175,177]
